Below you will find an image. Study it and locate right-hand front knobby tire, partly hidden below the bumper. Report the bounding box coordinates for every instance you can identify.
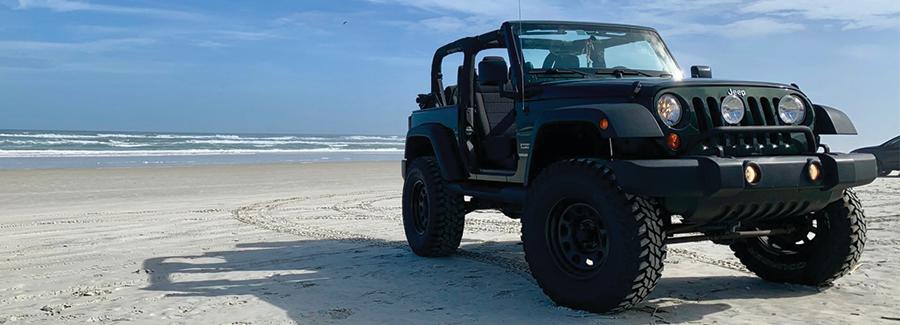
[731,189,866,287]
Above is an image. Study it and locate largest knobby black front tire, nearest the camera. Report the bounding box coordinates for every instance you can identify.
[522,160,666,313]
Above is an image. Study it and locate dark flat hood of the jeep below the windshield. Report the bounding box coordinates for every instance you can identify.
[526,78,799,100]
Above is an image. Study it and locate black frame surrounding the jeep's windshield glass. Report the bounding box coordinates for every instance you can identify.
[509,21,684,85]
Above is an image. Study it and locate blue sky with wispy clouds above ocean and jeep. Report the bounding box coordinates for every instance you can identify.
[0,0,900,148]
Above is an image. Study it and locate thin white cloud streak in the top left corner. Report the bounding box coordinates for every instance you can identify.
[14,0,204,20]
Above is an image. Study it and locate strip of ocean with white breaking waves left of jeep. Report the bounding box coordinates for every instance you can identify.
[0,130,404,169]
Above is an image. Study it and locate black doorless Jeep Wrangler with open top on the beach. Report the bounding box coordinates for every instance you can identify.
[402,21,877,312]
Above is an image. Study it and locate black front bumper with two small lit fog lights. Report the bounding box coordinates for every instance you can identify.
[608,153,877,222]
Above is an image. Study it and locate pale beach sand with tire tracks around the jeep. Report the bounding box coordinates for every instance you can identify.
[0,162,900,324]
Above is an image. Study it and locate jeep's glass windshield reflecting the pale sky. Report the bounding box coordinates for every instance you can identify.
[513,24,681,83]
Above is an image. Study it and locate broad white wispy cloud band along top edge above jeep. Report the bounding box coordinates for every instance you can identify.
[368,0,900,37]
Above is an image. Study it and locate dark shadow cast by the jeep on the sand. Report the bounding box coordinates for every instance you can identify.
[143,240,816,324]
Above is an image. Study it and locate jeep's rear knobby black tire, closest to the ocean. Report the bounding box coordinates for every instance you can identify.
[403,157,465,257]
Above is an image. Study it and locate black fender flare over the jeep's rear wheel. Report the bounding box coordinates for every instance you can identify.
[403,123,468,181]
